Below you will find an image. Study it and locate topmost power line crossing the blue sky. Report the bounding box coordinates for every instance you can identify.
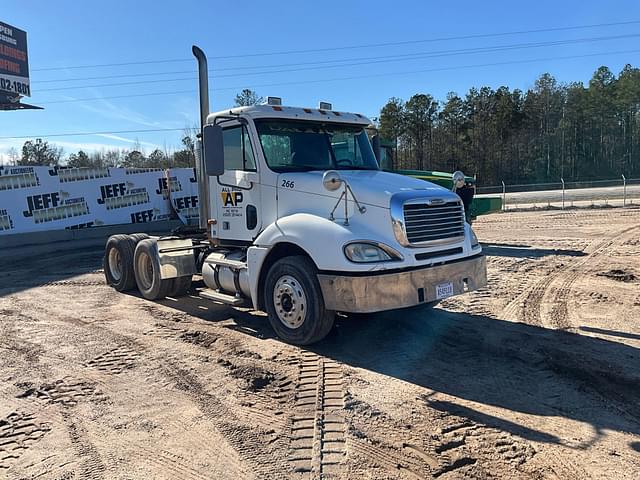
[32,20,640,72]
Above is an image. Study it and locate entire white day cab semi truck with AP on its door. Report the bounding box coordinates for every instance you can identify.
[104,47,486,344]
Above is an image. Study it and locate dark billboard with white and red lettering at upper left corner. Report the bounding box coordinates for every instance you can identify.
[0,22,31,97]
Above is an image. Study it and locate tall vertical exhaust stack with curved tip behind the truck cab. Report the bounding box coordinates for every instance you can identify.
[191,45,209,231]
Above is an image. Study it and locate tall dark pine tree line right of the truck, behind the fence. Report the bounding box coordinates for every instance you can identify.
[378,65,640,185]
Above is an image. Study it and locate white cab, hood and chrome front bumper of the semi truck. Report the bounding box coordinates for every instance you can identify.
[203,104,486,338]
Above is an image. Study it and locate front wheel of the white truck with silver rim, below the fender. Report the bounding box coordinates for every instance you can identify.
[264,256,335,345]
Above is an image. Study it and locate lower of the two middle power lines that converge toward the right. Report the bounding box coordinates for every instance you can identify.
[35,33,640,92]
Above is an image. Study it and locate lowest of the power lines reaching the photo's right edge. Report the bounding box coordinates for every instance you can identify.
[30,49,640,105]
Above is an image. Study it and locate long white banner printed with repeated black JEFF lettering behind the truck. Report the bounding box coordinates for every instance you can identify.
[0,166,198,236]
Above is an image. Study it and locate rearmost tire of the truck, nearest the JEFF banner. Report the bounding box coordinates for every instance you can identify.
[103,235,136,292]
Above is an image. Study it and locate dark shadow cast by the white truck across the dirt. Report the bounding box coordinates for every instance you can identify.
[159,296,640,448]
